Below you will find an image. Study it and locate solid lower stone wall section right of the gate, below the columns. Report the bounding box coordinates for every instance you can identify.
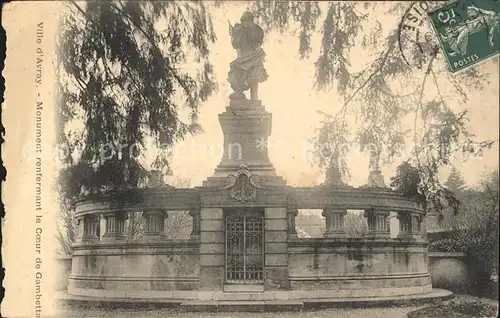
[288,239,432,298]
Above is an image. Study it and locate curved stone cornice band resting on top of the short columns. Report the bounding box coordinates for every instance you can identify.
[76,187,423,216]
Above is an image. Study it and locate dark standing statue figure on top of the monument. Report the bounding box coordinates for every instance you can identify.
[228,11,268,101]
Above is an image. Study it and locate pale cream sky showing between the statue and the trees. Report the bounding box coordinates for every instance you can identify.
[162,2,499,186]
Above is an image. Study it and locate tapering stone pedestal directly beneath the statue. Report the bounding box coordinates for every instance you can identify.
[214,100,276,177]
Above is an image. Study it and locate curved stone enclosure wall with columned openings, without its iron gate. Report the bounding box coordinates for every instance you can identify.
[68,184,432,299]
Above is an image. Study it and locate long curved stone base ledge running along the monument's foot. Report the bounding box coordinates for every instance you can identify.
[55,288,453,312]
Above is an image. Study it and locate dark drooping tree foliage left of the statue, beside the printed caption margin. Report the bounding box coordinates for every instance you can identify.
[58,1,216,191]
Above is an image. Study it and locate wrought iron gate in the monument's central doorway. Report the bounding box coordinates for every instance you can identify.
[226,213,264,284]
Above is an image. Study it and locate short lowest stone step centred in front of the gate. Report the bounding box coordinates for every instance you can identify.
[181,300,304,312]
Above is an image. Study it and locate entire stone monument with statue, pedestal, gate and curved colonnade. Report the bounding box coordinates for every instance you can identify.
[68,12,432,309]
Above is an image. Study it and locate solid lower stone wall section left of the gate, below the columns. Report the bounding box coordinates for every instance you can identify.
[68,240,200,298]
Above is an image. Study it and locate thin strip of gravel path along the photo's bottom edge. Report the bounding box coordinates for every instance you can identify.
[57,307,419,318]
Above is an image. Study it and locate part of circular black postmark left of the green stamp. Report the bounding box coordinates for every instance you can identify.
[398,1,446,69]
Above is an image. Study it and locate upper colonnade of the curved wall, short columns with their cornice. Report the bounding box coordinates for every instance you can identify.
[76,186,423,242]
